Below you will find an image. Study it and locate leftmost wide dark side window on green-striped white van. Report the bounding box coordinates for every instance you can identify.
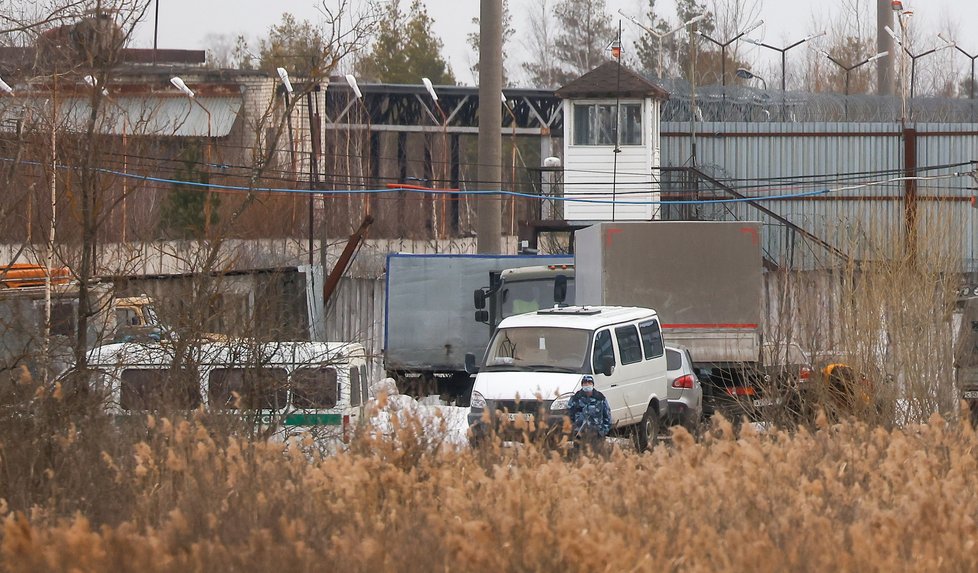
[119,368,200,410]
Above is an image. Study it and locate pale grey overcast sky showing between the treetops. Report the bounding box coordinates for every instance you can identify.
[134,0,978,84]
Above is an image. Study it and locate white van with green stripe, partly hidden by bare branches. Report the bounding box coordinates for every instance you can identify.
[80,340,369,440]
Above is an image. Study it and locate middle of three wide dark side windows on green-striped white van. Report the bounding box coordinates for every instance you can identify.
[207,368,288,410]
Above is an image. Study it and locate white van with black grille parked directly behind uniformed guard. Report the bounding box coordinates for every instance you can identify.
[467,306,668,449]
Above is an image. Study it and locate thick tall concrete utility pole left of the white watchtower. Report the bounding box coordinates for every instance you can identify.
[476,0,503,253]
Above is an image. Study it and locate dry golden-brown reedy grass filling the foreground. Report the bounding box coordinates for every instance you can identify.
[0,386,978,571]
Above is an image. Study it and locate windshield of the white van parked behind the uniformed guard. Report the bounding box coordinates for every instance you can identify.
[486,327,591,372]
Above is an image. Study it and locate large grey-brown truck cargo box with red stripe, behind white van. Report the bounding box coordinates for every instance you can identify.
[574,221,762,363]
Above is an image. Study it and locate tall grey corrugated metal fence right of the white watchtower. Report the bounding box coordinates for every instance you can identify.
[661,122,978,272]
